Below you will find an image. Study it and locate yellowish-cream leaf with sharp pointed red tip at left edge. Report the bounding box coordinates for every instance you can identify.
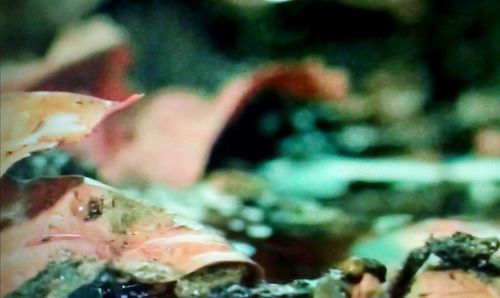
[0,92,139,175]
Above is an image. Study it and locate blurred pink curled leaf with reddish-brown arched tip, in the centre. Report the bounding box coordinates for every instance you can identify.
[74,61,347,187]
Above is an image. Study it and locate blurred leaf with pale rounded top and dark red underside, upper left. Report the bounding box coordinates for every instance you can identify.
[0,16,131,100]
